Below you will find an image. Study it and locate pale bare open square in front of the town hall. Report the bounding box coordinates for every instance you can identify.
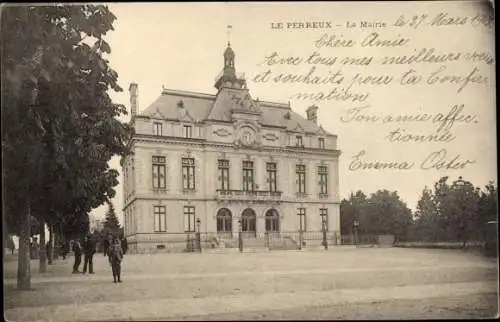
[4,247,498,321]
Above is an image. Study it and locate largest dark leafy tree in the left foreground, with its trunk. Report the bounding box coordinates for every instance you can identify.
[1,5,132,289]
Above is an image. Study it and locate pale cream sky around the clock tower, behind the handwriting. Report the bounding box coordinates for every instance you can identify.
[91,1,497,224]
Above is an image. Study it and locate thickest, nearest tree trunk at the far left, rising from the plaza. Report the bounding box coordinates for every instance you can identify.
[17,201,31,290]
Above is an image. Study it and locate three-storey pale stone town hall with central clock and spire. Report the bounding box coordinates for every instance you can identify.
[123,44,340,253]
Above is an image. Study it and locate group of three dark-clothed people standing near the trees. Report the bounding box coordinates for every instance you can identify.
[72,235,128,283]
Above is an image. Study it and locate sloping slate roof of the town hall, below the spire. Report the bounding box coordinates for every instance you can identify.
[139,89,332,135]
